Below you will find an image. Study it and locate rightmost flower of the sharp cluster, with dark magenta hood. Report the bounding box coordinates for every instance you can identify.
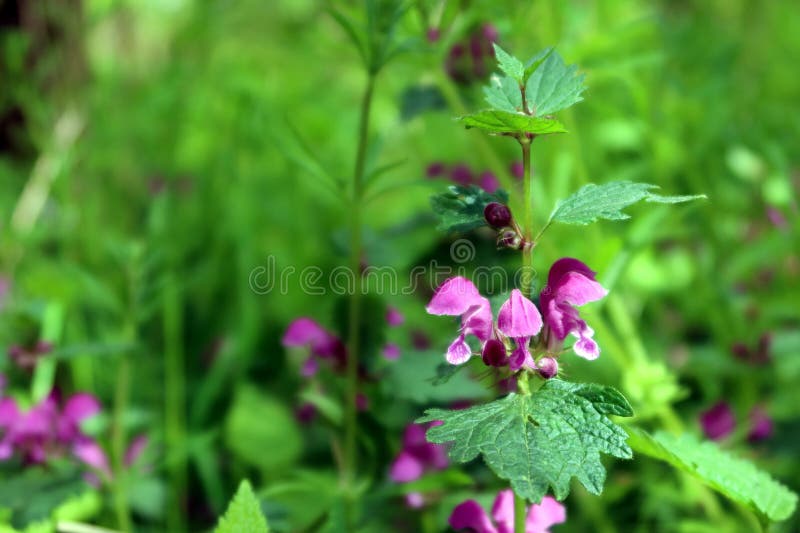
[540,257,608,360]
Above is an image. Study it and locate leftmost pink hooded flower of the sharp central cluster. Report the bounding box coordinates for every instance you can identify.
[425,276,492,365]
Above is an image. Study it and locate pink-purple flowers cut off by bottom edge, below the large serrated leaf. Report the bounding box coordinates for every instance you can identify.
[448,489,567,533]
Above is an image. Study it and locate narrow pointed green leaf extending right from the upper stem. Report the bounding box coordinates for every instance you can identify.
[550,181,706,225]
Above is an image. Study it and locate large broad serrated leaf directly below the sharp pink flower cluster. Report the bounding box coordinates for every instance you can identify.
[417,379,633,502]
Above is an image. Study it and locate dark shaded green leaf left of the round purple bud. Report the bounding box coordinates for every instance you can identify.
[431,185,508,233]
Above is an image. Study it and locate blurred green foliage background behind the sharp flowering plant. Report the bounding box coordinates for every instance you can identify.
[0,0,800,532]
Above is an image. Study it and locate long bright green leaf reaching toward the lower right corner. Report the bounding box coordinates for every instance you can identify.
[628,428,797,522]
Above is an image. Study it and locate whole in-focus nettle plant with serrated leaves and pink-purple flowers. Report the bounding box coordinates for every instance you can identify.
[417,45,797,533]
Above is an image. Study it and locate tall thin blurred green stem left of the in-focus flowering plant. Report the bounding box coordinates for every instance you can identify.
[342,73,375,530]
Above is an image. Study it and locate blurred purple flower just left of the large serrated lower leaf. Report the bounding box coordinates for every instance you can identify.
[389,421,449,483]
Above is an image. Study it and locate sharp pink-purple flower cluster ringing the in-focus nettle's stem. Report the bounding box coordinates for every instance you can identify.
[426,258,607,378]
